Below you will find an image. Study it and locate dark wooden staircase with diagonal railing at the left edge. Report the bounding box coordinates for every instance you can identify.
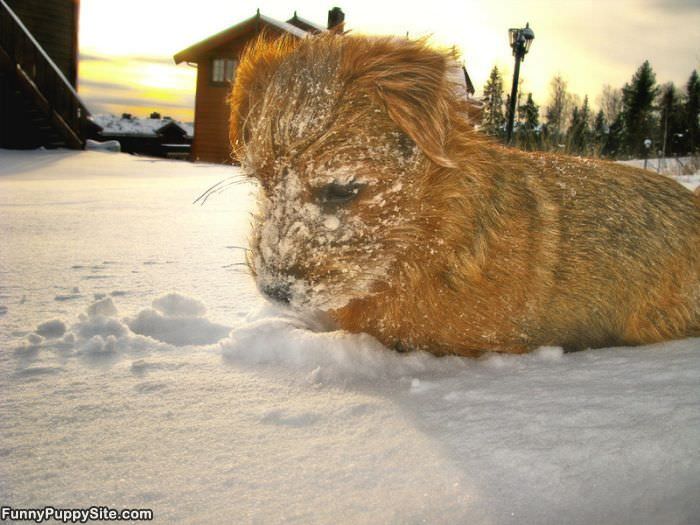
[0,0,94,149]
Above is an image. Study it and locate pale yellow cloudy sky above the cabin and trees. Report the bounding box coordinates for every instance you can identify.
[79,0,700,121]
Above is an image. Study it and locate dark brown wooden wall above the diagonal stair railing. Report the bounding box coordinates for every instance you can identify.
[6,0,79,86]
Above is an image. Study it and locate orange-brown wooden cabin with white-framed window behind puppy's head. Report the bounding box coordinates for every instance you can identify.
[173,7,345,163]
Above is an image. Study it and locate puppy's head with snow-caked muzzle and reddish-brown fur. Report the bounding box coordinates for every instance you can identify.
[232,36,460,310]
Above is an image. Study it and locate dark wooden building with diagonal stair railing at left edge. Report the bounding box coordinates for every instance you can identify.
[0,0,95,148]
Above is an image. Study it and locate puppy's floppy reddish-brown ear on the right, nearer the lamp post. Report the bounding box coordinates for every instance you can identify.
[343,38,455,167]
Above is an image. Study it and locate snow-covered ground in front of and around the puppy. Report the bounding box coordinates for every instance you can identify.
[0,151,700,524]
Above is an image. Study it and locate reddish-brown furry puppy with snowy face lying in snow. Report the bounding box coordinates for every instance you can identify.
[231,35,700,356]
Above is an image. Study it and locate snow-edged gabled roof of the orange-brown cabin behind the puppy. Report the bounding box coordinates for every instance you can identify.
[173,10,316,64]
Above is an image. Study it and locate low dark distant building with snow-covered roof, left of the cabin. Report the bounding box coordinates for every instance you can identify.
[91,113,194,159]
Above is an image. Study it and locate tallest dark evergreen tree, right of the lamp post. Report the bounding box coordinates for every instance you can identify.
[622,60,659,156]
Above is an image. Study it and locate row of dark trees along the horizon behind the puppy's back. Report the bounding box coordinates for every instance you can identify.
[481,61,700,159]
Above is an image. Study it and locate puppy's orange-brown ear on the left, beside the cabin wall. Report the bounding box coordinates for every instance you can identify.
[229,32,296,160]
